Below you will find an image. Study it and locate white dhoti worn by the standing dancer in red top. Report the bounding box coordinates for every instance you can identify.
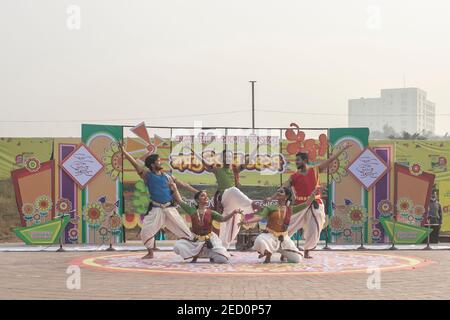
[288,204,325,250]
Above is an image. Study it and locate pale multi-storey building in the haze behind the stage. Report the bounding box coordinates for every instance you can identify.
[348,88,436,134]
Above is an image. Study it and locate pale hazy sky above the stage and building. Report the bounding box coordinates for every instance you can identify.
[0,0,450,136]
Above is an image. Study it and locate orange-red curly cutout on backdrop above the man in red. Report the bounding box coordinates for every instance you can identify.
[284,123,328,162]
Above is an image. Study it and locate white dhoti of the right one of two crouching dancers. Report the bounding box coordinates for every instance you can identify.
[253,233,303,263]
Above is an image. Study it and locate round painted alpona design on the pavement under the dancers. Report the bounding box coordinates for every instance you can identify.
[70,251,431,276]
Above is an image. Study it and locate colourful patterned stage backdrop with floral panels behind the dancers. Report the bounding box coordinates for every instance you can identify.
[0,129,450,244]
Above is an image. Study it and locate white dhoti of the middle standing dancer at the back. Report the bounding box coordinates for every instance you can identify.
[219,187,253,249]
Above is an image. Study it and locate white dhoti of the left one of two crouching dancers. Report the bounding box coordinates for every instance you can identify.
[173,233,230,263]
